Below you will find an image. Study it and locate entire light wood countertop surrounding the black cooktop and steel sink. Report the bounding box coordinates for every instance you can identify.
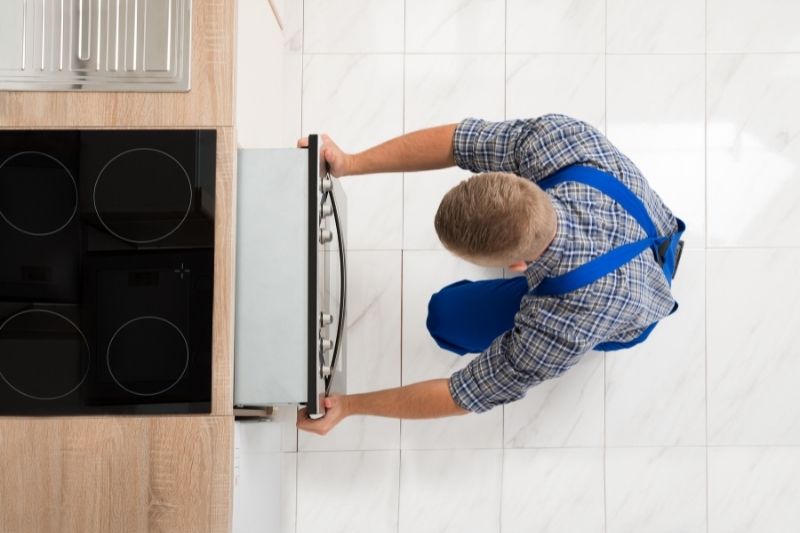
[0,0,236,533]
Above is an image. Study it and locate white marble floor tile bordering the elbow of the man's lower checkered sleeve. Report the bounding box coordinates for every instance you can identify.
[503,352,603,448]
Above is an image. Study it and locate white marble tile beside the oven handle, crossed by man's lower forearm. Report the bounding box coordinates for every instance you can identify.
[299,251,402,451]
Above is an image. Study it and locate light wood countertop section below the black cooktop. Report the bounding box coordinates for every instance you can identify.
[0,416,233,533]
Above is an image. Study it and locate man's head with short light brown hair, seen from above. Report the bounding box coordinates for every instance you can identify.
[434,172,556,272]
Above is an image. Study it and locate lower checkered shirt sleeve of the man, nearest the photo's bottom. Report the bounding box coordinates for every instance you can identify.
[449,296,602,413]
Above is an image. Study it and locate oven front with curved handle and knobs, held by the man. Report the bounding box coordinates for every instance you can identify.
[307,135,347,418]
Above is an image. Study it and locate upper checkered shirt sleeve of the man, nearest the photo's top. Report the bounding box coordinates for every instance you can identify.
[453,114,624,181]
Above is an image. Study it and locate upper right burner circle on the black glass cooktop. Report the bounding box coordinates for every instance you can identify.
[92,148,194,244]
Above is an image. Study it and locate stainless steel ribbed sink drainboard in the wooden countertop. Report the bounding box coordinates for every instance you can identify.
[0,0,192,92]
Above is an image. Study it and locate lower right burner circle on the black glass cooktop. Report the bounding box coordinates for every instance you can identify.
[106,315,189,396]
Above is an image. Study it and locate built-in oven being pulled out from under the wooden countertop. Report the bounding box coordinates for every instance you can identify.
[234,135,347,417]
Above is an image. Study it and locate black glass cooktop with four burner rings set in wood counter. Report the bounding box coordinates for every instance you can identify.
[0,130,216,415]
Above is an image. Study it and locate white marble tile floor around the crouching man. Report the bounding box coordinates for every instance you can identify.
[240,0,800,533]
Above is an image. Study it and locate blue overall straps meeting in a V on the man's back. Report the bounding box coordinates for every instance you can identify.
[531,165,659,296]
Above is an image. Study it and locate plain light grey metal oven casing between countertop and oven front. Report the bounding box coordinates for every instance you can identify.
[234,149,309,406]
